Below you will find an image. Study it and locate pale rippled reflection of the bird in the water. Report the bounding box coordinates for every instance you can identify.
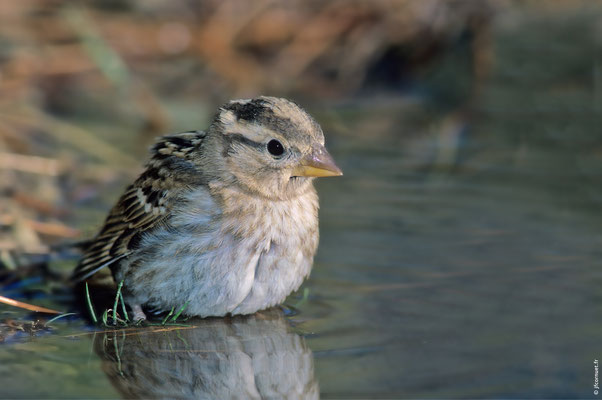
[94,309,319,399]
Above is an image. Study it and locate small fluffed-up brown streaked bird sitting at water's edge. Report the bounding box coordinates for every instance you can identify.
[72,96,343,320]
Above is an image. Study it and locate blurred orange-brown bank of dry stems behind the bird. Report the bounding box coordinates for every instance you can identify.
[0,0,496,254]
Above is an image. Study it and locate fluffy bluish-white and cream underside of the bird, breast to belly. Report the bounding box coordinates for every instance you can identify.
[116,186,318,317]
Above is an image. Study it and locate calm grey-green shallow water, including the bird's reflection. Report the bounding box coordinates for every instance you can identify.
[0,4,602,398]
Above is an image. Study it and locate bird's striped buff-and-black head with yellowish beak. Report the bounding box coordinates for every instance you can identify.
[208,97,343,200]
